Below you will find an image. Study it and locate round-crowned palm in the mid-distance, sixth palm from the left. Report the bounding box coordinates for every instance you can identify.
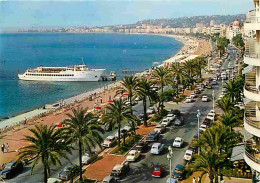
[152,67,173,113]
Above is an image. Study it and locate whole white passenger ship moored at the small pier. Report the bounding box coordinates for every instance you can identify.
[18,64,105,81]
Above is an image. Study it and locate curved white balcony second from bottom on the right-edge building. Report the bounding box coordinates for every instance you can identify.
[244,102,260,137]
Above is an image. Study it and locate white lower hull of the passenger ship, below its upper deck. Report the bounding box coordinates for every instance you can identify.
[18,69,105,82]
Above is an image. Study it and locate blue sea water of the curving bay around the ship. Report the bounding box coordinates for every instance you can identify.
[0,33,182,118]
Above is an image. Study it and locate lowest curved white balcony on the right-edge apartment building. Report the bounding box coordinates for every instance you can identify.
[244,138,260,172]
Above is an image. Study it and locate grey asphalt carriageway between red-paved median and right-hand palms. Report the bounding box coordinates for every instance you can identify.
[123,85,219,183]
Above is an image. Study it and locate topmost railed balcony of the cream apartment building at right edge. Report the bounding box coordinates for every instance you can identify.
[244,39,260,66]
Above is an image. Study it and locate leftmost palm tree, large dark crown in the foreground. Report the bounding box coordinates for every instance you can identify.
[19,124,73,183]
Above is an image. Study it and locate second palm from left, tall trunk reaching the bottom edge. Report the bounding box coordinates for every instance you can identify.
[62,108,104,181]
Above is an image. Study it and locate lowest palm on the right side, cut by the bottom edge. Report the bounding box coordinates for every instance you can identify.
[190,148,226,183]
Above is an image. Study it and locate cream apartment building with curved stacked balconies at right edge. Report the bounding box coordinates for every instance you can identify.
[244,0,260,182]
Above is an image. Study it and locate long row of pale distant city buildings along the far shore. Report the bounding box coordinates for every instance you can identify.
[20,20,245,40]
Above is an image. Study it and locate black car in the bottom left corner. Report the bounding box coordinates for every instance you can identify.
[0,161,23,179]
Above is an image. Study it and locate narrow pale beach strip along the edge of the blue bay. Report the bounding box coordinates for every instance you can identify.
[0,33,199,130]
